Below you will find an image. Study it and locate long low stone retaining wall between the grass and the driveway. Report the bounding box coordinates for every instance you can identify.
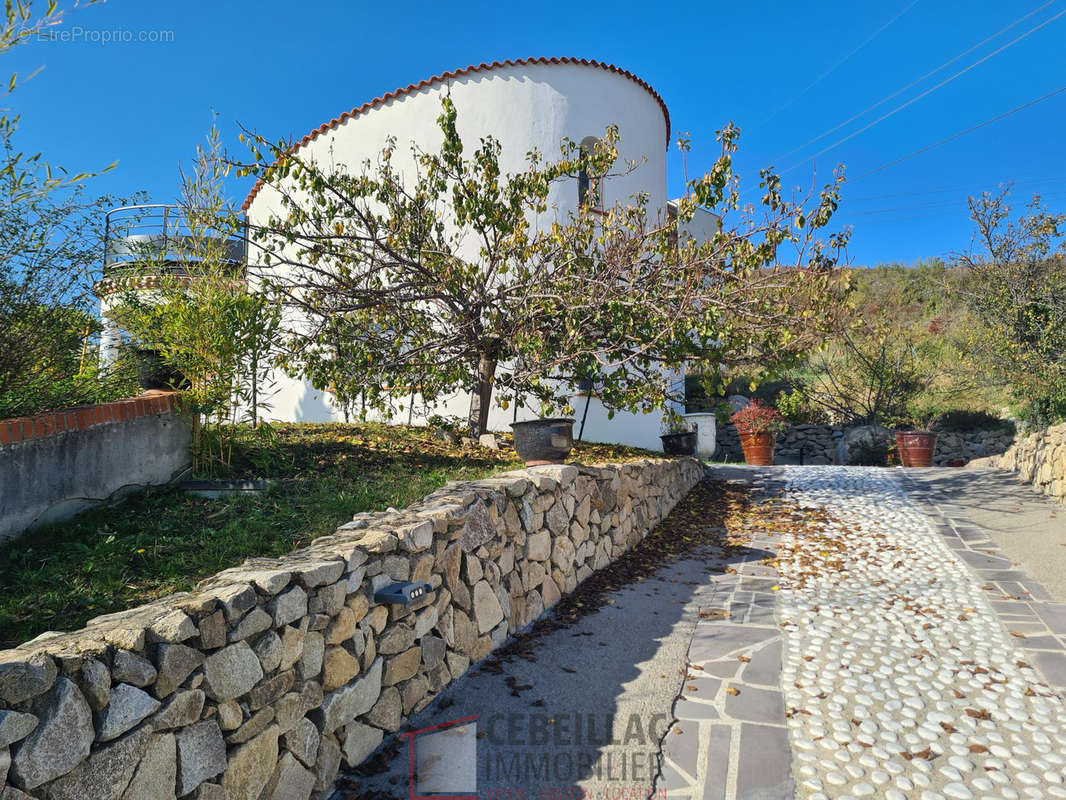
[0,459,701,800]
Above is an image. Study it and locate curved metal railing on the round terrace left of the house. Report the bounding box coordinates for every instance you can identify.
[103,204,247,277]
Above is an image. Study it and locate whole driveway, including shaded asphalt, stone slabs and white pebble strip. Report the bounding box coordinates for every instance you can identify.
[342,466,1066,800]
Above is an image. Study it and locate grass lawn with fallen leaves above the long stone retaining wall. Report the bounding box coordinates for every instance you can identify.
[0,425,661,649]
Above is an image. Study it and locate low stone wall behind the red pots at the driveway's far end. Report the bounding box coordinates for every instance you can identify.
[715,422,1014,466]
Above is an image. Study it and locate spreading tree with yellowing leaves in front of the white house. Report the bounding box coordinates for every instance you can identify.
[238,102,846,432]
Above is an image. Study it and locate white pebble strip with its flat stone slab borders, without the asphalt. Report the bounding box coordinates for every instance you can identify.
[657,466,1066,800]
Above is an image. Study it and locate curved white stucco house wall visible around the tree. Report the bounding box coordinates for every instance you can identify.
[247,63,668,449]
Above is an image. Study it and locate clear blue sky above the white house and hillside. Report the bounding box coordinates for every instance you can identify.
[5,0,1066,265]
